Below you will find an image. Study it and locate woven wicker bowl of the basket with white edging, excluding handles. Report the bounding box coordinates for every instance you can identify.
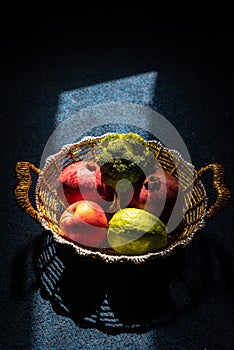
[36,136,207,262]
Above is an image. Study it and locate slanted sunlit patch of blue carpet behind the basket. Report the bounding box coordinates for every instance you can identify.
[55,71,158,126]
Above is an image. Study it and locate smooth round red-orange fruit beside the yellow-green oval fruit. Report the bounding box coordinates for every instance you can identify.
[60,200,108,247]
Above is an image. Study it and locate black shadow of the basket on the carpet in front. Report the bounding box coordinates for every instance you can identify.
[34,230,190,333]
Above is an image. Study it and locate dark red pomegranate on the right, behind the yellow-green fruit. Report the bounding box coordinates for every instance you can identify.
[129,169,182,224]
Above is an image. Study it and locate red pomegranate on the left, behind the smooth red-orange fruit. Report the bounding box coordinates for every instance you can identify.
[57,160,113,205]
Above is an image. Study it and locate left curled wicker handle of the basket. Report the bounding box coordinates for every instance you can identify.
[15,162,40,222]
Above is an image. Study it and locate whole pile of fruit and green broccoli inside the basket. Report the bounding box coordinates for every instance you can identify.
[57,133,178,255]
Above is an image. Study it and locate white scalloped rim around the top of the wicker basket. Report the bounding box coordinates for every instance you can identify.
[35,132,208,264]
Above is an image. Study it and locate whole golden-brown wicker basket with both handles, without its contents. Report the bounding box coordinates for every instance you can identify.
[15,135,230,263]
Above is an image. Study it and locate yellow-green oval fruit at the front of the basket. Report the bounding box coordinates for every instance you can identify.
[107,208,167,255]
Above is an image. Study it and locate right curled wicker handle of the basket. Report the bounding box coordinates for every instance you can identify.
[197,163,231,219]
